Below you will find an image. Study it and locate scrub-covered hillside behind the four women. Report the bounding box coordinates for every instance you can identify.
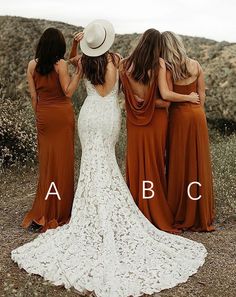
[0,16,236,170]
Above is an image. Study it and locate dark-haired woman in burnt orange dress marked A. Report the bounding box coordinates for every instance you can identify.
[22,28,80,232]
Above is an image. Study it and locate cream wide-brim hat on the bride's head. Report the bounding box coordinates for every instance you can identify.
[80,20,115,57]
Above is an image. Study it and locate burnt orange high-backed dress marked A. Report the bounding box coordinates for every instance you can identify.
[22,66,74,231]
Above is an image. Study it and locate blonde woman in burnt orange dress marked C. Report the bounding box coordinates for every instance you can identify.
[159,32,214,231]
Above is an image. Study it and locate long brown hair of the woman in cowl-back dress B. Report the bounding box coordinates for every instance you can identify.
[124,29,161,85]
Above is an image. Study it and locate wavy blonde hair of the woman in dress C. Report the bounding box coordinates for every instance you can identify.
[161,31,191,81]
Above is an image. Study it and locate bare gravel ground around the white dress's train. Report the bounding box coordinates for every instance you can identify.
[0,168,236,297]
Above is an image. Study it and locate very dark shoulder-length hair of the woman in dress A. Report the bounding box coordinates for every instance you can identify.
[35,28,66,75]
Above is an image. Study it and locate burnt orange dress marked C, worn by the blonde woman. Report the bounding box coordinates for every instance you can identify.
[167,80,214,231]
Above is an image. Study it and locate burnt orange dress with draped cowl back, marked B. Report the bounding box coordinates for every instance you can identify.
[120,71,177,232]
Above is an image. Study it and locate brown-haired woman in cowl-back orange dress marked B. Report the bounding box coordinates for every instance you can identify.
[120,29,198,232]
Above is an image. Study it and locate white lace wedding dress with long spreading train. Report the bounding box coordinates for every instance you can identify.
[11,75,207,297]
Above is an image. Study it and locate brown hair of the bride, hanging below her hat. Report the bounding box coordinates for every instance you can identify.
[81,51,116,86]
